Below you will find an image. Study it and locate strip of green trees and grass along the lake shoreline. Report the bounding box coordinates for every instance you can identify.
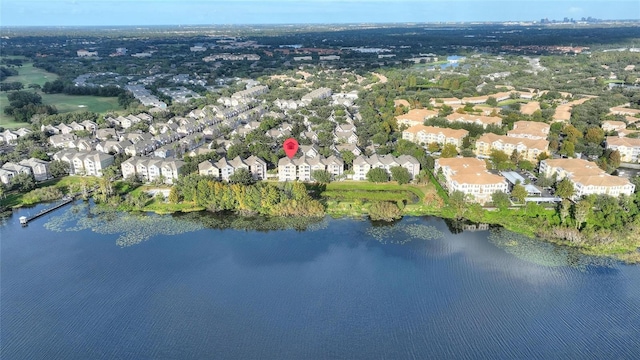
[5,175,640,263]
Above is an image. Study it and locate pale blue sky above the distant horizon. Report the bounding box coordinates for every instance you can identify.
[0,0,640,26]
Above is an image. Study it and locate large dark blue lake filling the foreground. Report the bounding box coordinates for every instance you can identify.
[0,202,640,359]
